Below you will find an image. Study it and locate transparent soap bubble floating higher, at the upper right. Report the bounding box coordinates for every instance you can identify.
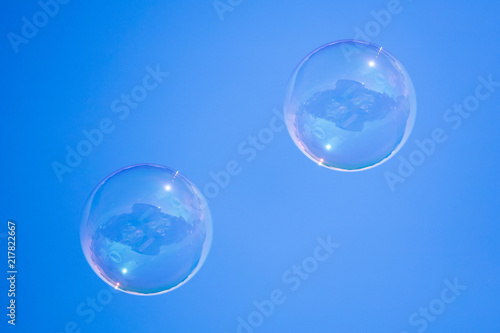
[284,40,416,171]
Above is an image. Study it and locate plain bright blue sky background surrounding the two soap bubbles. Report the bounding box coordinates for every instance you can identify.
[0,0,500,333]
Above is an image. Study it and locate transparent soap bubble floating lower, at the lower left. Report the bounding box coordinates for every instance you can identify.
[80,164,212,295]
